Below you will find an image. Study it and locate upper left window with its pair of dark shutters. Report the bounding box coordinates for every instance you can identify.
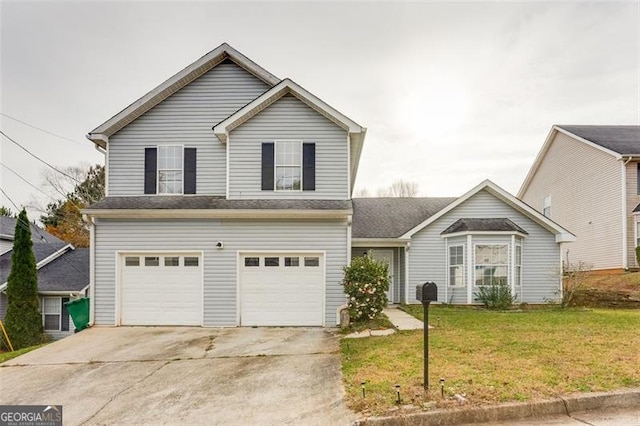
[144,145,196,194]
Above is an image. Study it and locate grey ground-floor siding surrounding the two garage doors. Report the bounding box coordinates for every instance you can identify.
[95,219,347,326]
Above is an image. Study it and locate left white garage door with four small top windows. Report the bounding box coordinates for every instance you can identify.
[120,253,203,325]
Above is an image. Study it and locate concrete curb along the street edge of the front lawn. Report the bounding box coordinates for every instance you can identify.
[354,388,640,426]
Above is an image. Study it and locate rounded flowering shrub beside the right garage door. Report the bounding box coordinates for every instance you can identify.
[342,256,389,322]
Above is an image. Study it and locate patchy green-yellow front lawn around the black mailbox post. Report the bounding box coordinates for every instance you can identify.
[341,305,640,414]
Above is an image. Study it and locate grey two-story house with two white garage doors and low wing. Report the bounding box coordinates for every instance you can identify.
[84,44,567,326]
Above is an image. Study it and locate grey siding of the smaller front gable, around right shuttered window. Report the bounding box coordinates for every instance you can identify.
[228,95,349,200]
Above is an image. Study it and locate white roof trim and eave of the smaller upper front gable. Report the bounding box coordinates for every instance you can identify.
[213,78,367,188]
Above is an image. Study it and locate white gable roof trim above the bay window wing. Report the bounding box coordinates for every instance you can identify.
[400,179,575,243]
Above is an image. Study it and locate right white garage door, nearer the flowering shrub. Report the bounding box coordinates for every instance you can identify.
[239,253,324,326]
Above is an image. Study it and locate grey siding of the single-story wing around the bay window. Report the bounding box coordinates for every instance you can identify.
[409,191,560,303]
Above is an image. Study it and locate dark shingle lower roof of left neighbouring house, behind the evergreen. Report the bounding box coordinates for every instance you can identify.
[0,243,89,291]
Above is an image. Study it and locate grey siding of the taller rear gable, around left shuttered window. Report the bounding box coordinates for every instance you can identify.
[108,62,268,196]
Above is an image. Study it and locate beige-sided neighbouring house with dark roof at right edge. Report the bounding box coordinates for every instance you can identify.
[518,125,640,270]
